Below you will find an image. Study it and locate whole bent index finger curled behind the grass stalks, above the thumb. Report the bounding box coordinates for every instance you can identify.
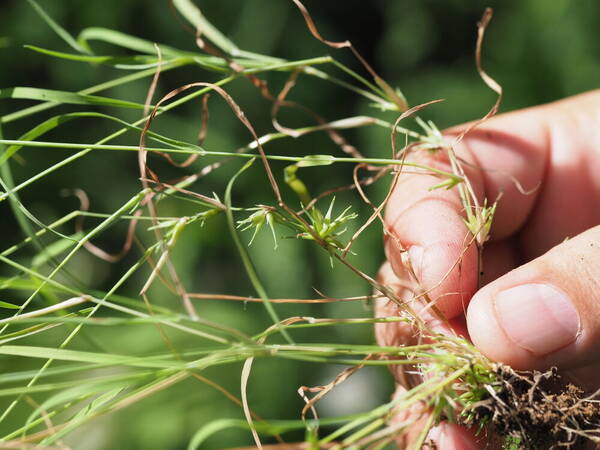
[385,100,552,318]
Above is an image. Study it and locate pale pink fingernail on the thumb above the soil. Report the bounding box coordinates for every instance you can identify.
[494,283,580,356]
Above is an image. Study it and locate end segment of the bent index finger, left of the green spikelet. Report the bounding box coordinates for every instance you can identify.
[385,149,477,318]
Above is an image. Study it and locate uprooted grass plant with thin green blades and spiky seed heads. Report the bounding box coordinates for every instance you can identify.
[0,0,598,449]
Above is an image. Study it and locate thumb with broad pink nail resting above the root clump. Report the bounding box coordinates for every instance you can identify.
[467,226,600,369]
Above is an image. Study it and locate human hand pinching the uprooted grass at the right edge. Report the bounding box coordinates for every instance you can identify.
[376,91,600,450]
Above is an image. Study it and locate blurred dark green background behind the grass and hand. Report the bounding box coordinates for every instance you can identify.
[0,0,600,449]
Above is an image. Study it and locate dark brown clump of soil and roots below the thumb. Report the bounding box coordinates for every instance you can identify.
[468,365,600,450]
